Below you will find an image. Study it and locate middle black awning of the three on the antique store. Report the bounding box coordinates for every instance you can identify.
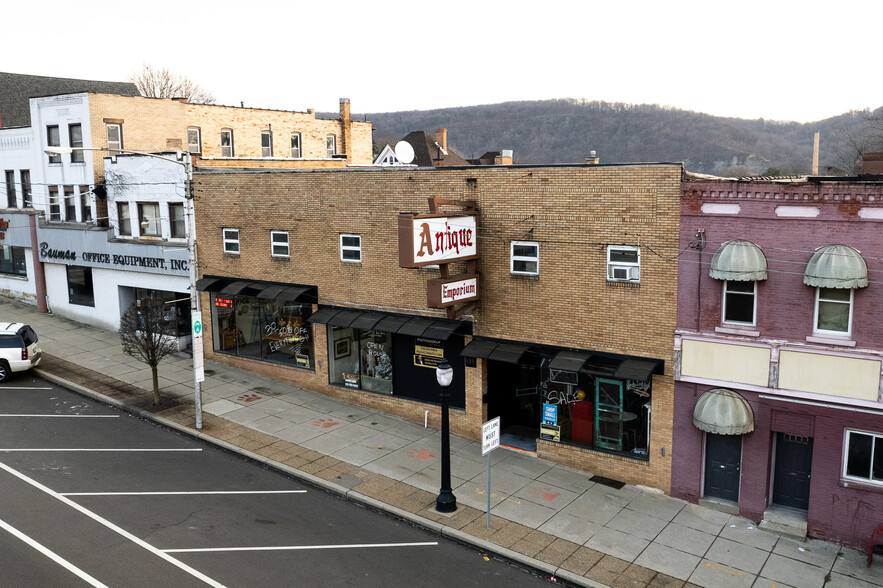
[307,307,472,341]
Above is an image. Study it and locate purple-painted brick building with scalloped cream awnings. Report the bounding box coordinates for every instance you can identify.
[672,176,883,546]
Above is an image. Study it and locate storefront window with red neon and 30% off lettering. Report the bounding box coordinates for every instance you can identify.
[212,294,314,369]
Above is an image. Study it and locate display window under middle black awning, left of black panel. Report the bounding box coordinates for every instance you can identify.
[328,327,393,394]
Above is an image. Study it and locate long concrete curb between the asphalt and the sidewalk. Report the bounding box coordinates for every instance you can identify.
[33,368,609,588]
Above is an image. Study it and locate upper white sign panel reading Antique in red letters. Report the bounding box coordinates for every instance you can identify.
[399,213,478,267]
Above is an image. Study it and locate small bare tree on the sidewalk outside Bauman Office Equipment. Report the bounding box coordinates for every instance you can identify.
[120,296,178,404]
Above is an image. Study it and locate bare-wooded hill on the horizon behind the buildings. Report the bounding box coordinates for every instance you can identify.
[358,99,872,175]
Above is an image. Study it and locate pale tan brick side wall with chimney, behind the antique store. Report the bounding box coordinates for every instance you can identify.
[83,94,372,179]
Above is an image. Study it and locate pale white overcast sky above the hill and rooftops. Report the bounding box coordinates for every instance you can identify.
[8,0,883,122]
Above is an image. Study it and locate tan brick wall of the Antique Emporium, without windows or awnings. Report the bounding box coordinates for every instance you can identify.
[196,164,681,492]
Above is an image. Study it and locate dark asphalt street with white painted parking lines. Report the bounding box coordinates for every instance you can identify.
[0,375,548,587]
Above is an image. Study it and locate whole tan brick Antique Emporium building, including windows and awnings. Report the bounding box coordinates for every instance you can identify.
[196,164,682,491]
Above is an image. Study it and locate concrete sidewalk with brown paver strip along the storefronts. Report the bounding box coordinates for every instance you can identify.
[6,298,883,588]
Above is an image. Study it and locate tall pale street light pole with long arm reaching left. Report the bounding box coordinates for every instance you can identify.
[44,147,202,429]
